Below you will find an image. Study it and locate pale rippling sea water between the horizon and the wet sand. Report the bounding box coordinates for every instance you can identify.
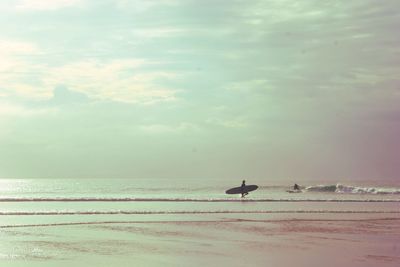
[0,179,400,221]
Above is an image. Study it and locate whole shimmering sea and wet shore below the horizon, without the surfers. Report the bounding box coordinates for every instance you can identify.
[0,179,400,266]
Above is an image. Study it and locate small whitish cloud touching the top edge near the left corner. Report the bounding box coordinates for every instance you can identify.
[16,0,82,10]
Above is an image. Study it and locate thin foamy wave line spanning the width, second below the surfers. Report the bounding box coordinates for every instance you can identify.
[0,210,400,216]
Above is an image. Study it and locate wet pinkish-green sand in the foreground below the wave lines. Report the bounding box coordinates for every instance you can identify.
[0,214,400,267]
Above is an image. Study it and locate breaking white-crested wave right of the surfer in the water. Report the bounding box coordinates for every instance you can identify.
[305,184,400,195]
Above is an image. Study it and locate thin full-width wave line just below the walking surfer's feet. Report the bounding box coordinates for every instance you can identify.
[0,197,400,202]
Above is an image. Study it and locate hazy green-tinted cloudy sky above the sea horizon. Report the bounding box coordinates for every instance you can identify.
[0,0,400,181]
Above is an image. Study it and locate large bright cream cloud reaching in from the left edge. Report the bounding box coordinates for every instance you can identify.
[0,40,177,104]
